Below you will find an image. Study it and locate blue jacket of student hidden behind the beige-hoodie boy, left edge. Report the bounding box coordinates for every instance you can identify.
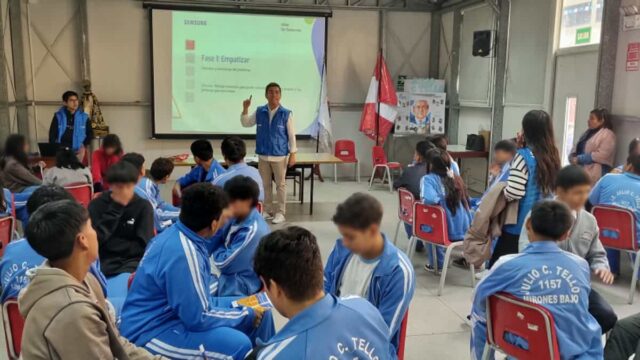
[0,238,107,303]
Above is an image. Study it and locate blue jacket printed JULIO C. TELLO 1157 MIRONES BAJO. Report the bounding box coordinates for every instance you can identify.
[471,241,602,360]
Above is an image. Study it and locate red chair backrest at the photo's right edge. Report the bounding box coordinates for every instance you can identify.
[591,205,638,251]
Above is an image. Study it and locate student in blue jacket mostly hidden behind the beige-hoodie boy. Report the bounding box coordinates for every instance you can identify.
[0,186,106,303]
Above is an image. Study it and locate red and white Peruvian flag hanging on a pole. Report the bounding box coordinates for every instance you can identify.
[360,52,398,144]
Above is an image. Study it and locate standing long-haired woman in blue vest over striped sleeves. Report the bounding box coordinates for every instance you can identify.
[489,110,560,267]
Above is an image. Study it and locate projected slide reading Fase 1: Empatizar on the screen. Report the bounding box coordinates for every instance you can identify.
[151,9,326,136]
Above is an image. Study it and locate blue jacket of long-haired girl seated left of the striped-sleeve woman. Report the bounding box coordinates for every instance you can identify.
[420,174,471,241]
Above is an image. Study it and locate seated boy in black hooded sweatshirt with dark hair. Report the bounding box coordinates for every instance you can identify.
[89,161,153,277]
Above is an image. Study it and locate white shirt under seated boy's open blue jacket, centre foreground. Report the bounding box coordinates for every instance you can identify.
[339,254,380,298]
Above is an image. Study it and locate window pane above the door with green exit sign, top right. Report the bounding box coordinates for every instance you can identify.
[560,0,604,48]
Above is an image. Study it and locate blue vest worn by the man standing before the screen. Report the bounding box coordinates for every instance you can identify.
[256,105,291,156]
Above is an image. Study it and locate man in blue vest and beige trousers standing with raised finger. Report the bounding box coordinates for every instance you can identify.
[240,83,297,224]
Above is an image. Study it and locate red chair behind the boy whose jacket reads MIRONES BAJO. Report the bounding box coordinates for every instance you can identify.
[482,293,560,360]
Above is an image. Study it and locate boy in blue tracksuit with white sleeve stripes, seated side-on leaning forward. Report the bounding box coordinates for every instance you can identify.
[120,183,273,359]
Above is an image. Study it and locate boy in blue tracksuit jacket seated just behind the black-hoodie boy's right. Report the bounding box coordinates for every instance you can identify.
[136,158,180,233]
